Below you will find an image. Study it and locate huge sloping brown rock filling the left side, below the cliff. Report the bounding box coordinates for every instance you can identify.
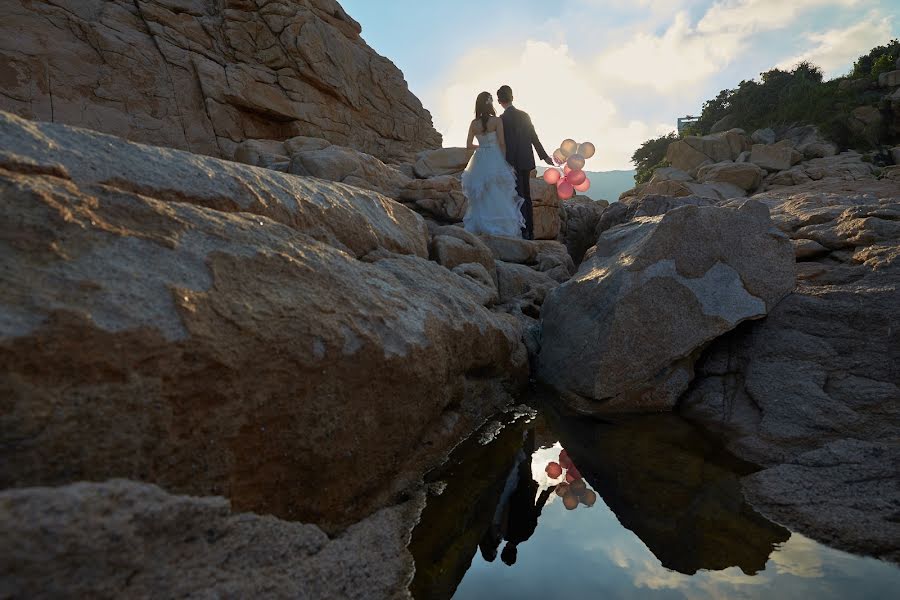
[0,113,527,527]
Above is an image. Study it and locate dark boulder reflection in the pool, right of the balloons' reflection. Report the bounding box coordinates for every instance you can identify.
[546,411,790,575]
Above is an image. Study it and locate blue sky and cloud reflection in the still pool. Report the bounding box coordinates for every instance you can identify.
[454,443,900,600]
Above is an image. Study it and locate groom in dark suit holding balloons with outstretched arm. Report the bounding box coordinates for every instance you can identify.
[497,85,553,240]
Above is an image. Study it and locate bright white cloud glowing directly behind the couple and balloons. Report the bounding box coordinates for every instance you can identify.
[425,41,673,171]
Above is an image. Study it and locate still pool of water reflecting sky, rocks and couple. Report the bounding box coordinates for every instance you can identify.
[410,394,900,600]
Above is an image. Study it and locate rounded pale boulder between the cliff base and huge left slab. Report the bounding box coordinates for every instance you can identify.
[288,144,412,197]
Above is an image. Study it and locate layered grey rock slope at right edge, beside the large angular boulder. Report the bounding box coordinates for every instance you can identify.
[680,179,900,561]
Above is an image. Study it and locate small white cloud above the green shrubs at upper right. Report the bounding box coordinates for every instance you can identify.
[778,13,892,77]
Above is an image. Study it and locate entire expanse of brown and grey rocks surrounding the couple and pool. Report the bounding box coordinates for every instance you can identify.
[0,0,900,598]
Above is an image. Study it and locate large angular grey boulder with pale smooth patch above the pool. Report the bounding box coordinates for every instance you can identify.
[538,200,794,414]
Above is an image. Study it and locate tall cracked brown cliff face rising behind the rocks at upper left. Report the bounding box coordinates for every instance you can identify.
[0,0,441,160]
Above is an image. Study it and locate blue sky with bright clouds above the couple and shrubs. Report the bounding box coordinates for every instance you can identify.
[340,0,900,171]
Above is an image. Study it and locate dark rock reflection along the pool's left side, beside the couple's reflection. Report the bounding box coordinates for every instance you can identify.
[409,412,533,600]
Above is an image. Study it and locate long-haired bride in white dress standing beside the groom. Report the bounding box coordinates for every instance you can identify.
[462,92,525,237]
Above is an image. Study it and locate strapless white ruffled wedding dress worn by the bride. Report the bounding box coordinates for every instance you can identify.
[462,132,525,237]
